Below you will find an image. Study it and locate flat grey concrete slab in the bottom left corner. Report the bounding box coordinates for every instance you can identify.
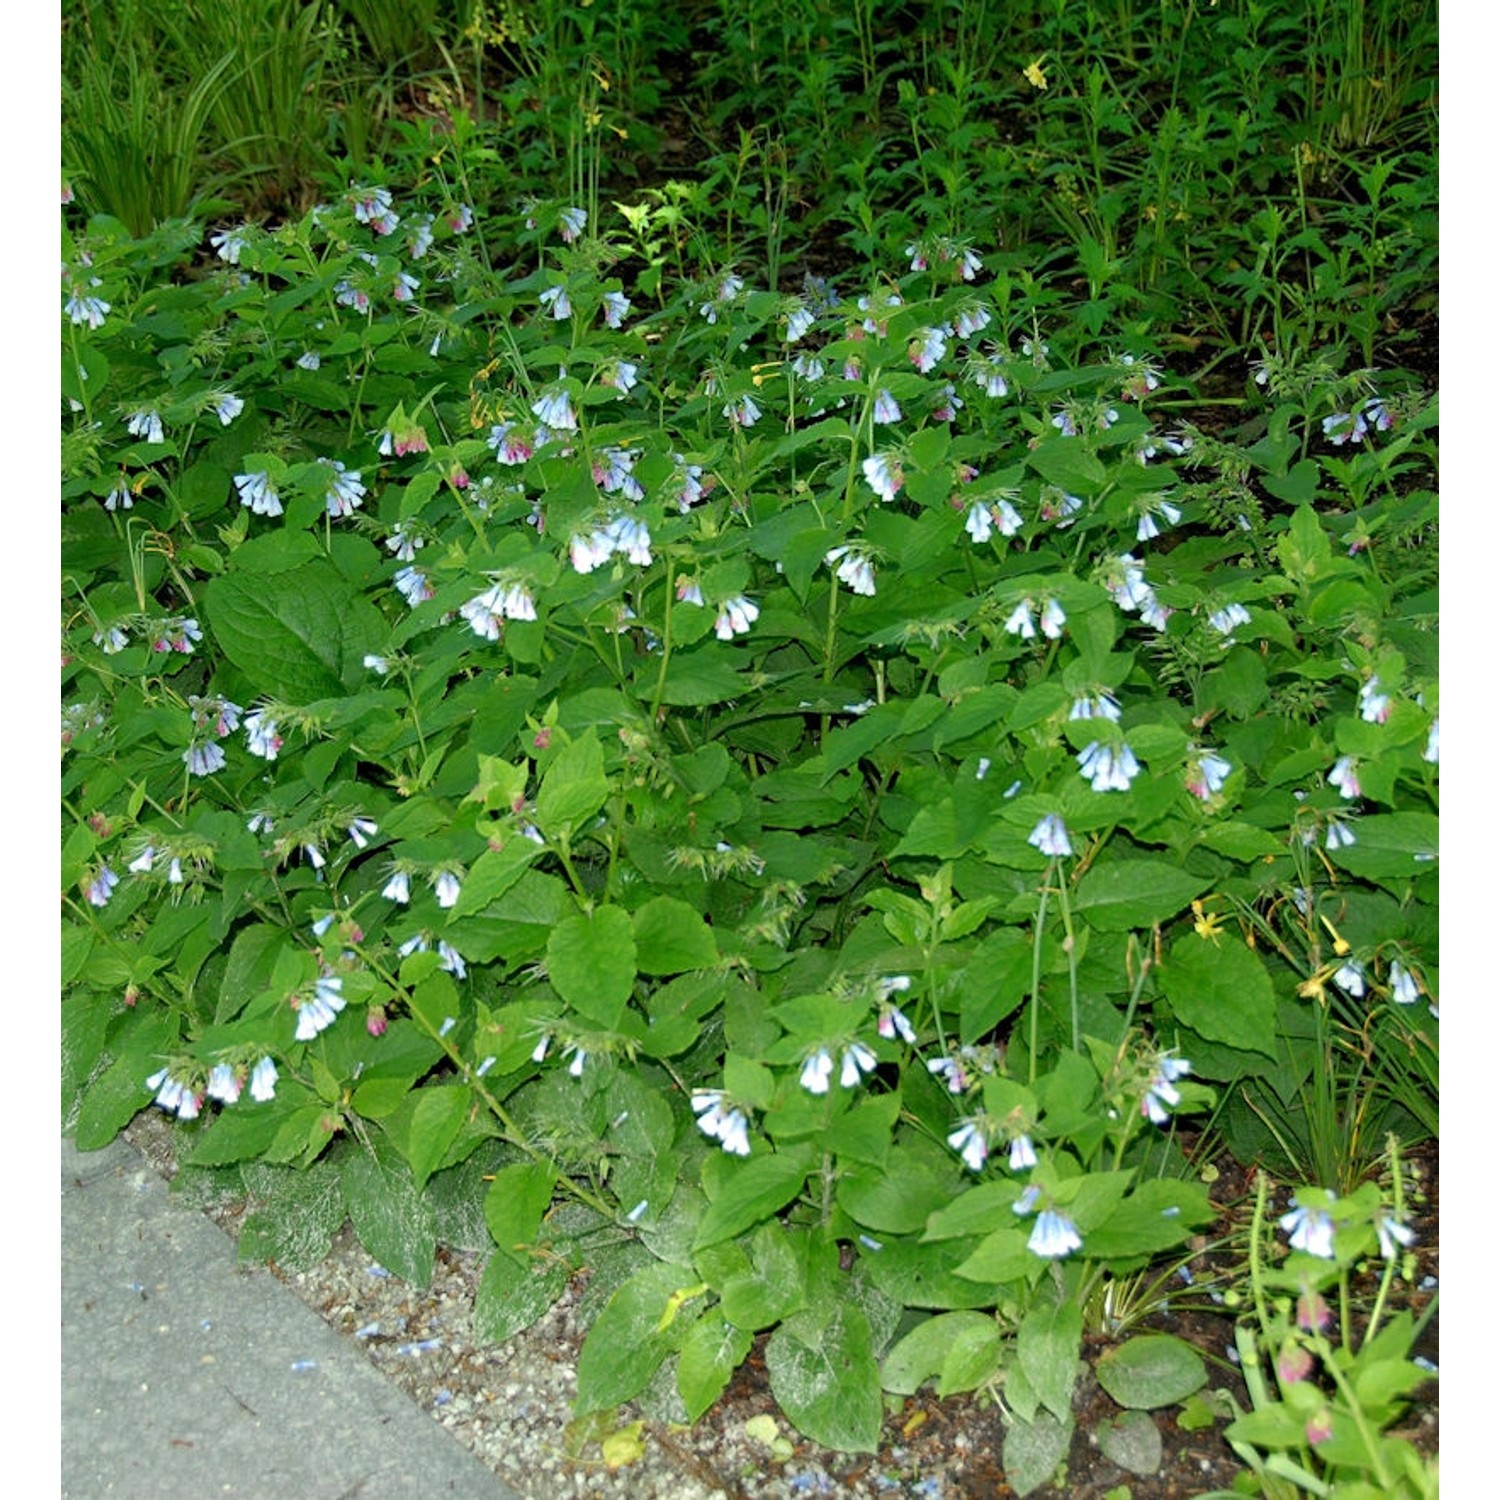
[62,1140,519,1500]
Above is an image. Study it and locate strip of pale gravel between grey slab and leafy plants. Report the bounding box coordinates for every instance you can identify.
[117,1112,1011,1500]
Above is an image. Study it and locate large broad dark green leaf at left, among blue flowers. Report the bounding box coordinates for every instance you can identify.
[203,560,387,704]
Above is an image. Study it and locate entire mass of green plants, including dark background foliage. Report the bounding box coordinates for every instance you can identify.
[62,3,1439,1496]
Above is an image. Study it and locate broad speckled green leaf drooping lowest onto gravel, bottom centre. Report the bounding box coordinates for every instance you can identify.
[765,1299,884,1454]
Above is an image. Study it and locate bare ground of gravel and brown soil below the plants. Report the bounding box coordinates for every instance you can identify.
[114,1112,1437,1500]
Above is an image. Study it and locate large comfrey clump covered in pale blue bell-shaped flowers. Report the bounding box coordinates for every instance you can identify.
[62,170,1437,1451]
